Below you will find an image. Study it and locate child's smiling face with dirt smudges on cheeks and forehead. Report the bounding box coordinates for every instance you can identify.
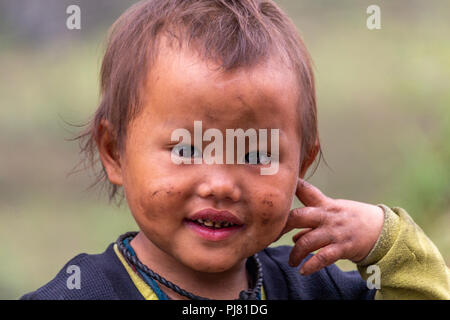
[109,42,300,272]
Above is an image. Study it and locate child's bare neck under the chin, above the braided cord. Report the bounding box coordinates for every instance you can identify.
[130,232,249,300]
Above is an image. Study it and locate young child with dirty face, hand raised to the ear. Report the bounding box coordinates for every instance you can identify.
[22,0,450,300]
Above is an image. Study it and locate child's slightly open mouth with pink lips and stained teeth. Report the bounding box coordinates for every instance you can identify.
[185,209,244,241]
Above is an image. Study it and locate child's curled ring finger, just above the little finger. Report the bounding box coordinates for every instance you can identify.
[289,228,333,267]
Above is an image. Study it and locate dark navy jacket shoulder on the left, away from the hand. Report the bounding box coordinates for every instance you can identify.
[20,244,139,300]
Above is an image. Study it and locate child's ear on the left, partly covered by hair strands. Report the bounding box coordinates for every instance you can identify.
[96,120,123,185]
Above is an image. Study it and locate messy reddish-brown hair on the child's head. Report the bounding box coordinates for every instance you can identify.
[70,0,322,205]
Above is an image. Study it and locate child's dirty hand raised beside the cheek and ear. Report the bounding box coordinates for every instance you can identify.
[280,179,384,275]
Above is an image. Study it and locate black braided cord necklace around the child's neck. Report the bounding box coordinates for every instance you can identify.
[116,232,263,300]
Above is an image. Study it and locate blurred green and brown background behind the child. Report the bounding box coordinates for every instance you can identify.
[0,0,450,299]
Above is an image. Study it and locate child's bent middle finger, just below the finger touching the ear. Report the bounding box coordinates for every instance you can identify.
[281,207,325,234]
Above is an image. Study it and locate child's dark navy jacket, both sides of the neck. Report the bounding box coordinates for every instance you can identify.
[21,244,376,300]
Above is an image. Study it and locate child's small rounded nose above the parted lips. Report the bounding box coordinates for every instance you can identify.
[197,169,242,202]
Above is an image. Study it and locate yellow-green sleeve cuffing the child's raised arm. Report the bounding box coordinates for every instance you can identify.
[357,204,450,300]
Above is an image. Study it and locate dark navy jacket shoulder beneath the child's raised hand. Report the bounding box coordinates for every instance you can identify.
[258,246,375,300]
